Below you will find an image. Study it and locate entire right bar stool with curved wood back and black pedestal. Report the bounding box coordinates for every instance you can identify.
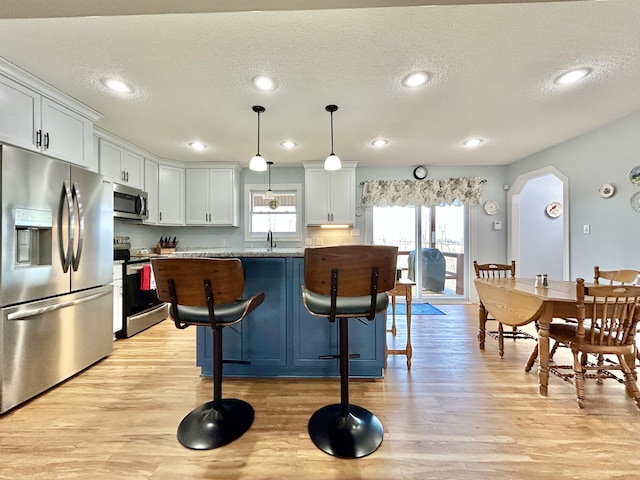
[302,245,398,458]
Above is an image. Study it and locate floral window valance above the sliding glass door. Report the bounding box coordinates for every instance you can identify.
[362,177,485,207]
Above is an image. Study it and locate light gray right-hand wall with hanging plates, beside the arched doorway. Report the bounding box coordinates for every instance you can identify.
[507,112,640,279]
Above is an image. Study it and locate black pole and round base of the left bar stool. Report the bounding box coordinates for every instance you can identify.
[178,326,255,450]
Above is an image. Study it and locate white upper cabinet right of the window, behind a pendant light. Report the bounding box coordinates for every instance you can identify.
[304,162,357,226]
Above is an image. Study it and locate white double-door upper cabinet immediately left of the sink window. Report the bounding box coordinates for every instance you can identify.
[185,166,239,227]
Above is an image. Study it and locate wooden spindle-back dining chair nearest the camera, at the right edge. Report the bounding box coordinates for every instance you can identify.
[525,278,640,408]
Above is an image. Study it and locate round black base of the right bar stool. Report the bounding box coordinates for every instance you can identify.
[308,403,384,458]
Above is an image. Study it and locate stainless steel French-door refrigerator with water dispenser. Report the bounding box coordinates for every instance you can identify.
[0,145,113,413]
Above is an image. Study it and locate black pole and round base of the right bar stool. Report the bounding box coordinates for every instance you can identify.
[308,318,383,458]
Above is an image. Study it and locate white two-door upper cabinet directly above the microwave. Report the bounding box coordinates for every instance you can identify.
[99,138,144,189]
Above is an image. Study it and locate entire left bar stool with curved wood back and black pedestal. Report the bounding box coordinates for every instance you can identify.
[151,258,264,450]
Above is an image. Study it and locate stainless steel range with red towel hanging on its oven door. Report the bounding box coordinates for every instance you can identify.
[113,237,168,338]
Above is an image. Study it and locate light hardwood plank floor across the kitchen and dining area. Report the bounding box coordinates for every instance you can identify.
[0,305,640,480]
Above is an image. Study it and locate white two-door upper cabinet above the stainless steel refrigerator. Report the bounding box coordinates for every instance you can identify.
[0,72,98,168]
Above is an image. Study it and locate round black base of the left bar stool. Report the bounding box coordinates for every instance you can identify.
[178,398,254,450]
